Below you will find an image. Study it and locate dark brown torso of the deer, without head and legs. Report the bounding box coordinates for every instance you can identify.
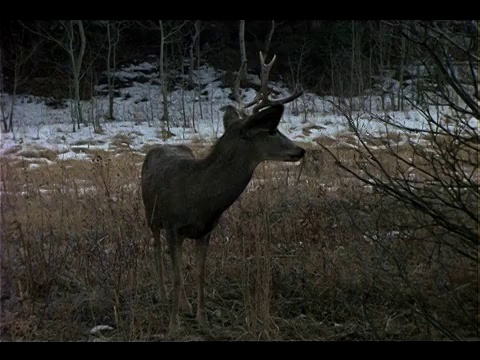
[142,138,258,239]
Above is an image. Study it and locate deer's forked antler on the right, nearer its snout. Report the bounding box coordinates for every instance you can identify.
[245,51,303,114]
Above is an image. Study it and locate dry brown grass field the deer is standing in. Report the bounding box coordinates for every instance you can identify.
[0,139,478,341]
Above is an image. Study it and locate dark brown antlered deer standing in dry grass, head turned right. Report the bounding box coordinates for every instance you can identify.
[141,52,305,333]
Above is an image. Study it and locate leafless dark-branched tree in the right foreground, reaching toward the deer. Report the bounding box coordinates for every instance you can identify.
[320,21,480,339]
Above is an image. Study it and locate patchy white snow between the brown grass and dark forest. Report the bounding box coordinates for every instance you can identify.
[0,62,478,163]
